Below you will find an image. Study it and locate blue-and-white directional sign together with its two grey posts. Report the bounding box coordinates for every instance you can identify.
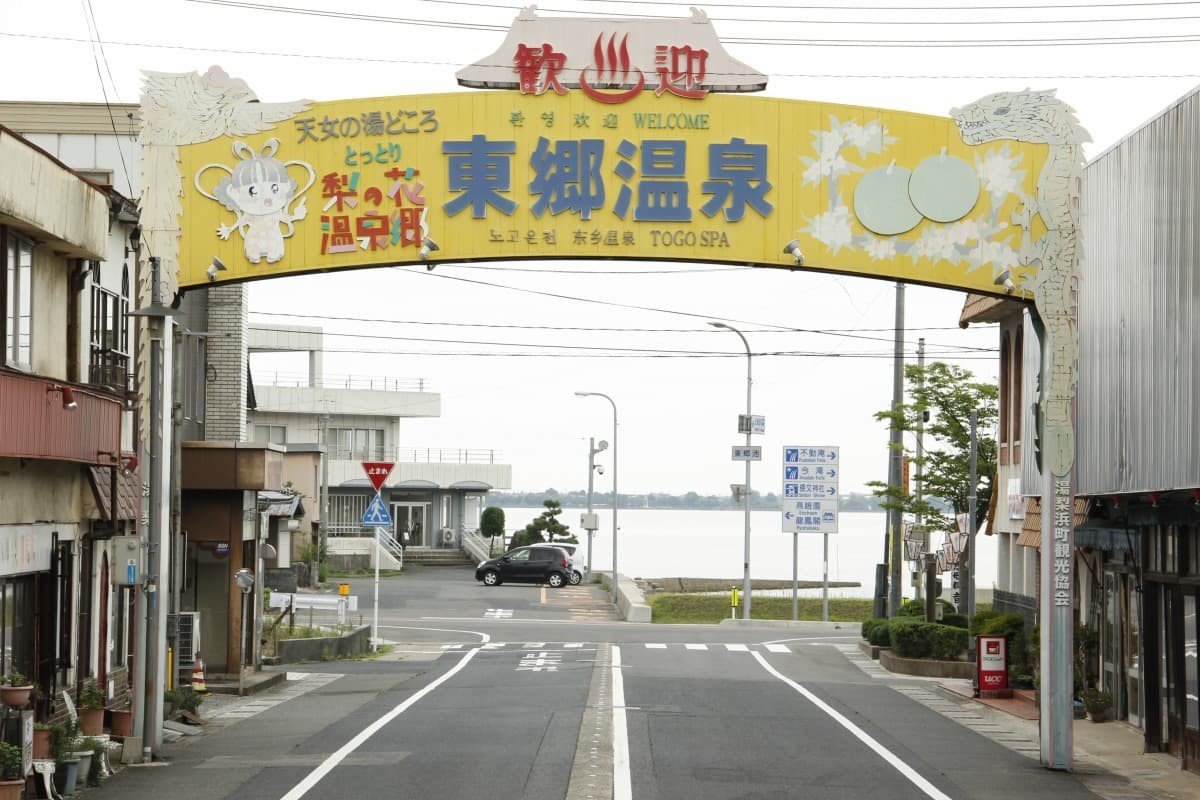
[784,445,841,621]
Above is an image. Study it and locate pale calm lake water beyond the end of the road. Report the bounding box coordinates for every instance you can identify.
[504,507,996,597]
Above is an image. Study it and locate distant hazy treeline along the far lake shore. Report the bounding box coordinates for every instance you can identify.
[485,489,881,511]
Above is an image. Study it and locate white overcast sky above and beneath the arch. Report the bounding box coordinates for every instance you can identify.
[0,0,1200,493]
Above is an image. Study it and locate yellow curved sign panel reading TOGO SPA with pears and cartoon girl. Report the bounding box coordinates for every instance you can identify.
[169,87,1048,296]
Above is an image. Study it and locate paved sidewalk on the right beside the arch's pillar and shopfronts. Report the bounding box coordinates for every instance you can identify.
[940,680,1200,800]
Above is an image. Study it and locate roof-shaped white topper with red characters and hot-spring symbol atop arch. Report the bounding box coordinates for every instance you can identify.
[455,6,767,94]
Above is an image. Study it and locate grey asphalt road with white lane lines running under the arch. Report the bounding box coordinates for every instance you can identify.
[84,567,1096,800]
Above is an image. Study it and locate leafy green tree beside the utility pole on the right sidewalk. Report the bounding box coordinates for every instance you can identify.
[870,361,1000,531]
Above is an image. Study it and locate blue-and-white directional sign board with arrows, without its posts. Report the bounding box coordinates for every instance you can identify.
[784,445,841,534]
